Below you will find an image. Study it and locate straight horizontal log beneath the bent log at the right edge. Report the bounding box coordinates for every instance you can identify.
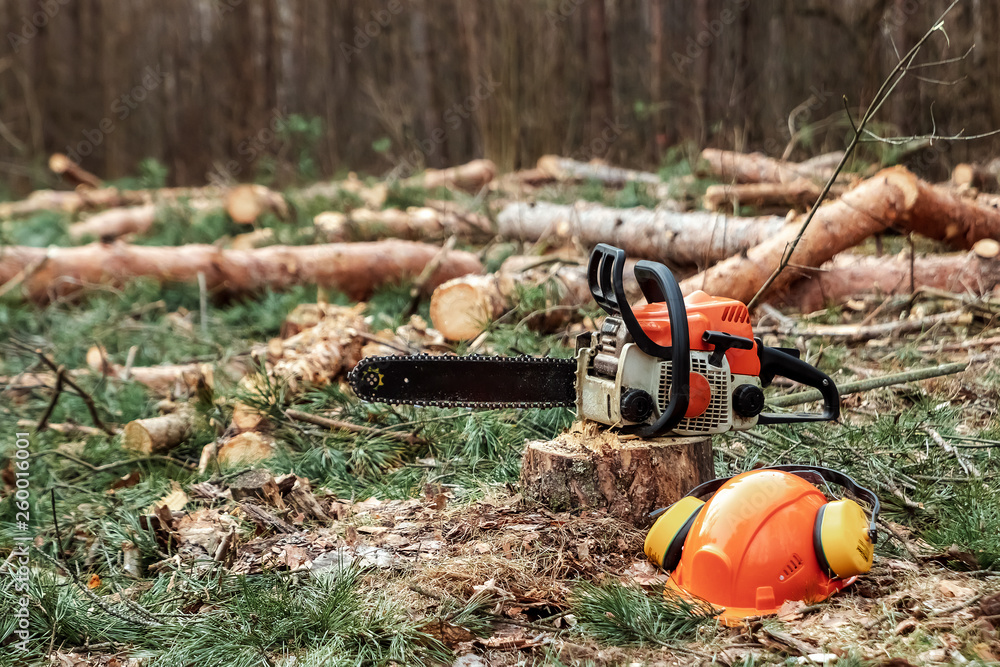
[769,252,1000,312]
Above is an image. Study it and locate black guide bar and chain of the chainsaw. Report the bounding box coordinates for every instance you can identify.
[347,354,577,410]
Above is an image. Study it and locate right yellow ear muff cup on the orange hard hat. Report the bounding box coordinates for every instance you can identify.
[813,498,875,579]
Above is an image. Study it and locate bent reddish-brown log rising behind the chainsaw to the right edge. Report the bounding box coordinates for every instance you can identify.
[681,167,1000,303]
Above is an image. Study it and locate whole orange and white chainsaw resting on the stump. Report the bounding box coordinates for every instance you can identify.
[348,244,840,437]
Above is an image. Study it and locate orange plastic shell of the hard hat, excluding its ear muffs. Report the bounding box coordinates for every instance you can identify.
[651,470,856,623]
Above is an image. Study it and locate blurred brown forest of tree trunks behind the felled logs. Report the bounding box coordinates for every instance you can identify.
[0,0,1000,196]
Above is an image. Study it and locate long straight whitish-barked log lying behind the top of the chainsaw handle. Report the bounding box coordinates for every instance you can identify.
[497,202,786,266]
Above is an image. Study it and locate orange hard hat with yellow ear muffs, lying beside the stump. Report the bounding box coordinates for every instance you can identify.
[645,466,879,624]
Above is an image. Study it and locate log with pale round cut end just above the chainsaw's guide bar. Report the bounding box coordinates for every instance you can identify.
[430,256,596,340]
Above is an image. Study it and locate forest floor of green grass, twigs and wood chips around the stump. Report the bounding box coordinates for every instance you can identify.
[0,163,1000,667]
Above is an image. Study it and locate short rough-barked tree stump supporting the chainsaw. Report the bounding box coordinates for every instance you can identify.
[521,422,714,525]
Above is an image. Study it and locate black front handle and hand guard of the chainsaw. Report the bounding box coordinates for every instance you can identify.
[587,243,691,438]
